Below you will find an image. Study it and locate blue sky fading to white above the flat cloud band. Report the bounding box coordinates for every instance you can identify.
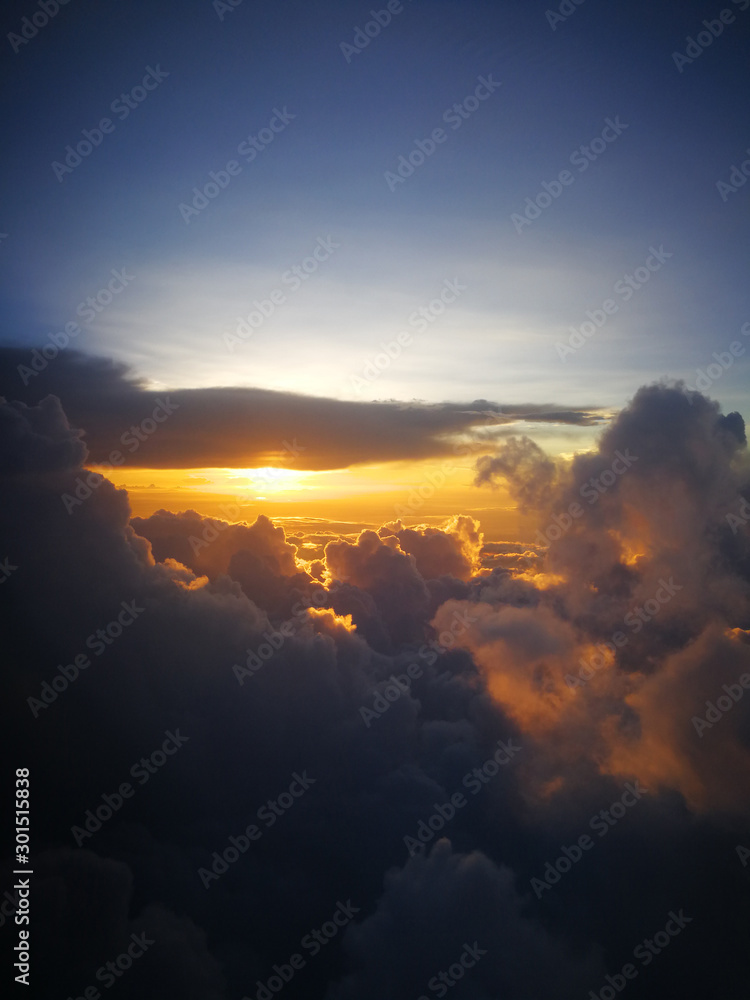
[0,0,750,426]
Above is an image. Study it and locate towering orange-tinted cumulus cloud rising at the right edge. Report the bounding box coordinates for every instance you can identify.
[458,385,750,811]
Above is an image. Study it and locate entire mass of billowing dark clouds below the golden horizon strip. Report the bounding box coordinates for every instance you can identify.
[0,380,750,1000]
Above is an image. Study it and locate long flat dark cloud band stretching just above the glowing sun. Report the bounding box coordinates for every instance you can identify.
[0,347,602,470]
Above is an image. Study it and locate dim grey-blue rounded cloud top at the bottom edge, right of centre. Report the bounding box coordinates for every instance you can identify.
[326,840,603,1000]
